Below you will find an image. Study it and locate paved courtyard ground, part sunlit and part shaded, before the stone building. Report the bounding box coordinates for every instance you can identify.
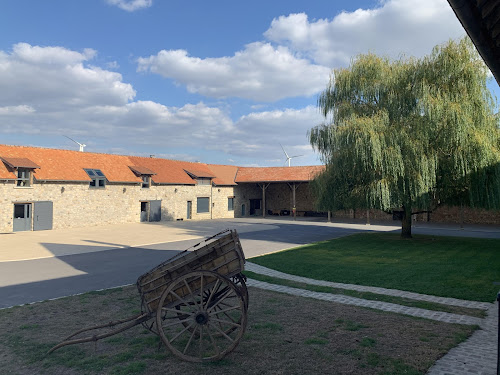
[0,217,500,308]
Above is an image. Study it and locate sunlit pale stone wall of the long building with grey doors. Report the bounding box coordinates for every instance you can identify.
[0,181,236,232]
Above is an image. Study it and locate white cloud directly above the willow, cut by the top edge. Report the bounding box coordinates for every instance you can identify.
[264,0,465,67]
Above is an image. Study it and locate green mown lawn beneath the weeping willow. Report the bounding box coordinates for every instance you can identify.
[251,233,500,302]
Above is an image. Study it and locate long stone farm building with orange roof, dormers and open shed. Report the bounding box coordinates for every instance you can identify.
[0,145,322,232]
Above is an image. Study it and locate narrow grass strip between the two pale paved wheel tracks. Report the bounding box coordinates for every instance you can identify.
[244,271,486,318]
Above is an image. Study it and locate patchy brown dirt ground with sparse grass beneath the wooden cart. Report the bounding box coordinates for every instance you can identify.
[0,287,475,375]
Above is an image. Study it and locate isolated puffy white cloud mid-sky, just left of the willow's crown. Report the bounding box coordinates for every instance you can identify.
[138,42,330,102]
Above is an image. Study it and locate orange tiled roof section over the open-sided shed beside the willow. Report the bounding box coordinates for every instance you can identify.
[235,165,325,183]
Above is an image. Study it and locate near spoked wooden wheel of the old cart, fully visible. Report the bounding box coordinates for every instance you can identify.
[156,271,247,362]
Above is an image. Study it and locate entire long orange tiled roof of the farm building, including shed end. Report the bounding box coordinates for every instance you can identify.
[0,145,324,186]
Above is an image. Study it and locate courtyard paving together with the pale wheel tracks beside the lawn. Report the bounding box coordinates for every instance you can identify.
[0,218,500,375]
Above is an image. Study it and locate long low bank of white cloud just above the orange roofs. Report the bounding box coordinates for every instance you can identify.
[0,44,322,165]
